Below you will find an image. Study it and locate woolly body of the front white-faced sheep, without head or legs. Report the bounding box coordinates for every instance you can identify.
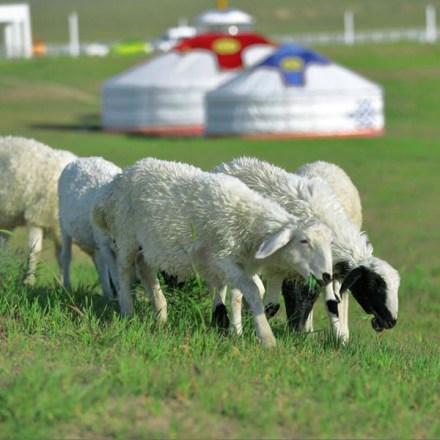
[93,158,295,276]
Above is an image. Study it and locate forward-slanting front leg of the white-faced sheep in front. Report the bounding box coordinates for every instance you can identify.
[223,263,276,347]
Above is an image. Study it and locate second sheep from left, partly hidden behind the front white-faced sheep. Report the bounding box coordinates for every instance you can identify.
[58,157,122,301]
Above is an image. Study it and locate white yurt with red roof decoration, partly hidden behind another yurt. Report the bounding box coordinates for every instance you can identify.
[101,32,274,135]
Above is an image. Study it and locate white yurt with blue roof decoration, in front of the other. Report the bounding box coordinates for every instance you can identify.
[205,44,384,137]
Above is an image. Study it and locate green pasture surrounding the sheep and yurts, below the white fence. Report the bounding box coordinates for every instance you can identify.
[0,45,440,439]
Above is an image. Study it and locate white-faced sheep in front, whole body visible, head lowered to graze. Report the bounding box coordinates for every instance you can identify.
[92,158,332,346]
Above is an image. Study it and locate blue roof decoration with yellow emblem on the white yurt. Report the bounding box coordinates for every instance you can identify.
[256,44,329,87]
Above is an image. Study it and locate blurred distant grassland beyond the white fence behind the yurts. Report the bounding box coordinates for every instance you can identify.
[18,0,440,42]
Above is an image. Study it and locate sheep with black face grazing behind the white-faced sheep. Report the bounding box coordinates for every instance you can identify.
[214,157,399,342]
